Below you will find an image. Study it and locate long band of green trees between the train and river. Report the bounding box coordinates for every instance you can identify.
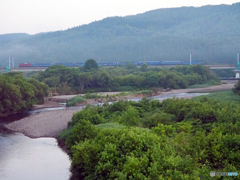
[35,61,220,95]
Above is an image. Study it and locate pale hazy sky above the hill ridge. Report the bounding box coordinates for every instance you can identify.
[0,0,240,34]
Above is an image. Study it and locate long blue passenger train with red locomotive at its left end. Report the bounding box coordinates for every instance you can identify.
[19,61,205,67]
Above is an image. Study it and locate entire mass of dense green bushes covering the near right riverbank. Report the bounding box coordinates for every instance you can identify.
[59,97,240,180]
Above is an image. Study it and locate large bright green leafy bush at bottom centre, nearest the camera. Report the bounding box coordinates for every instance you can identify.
[72,128,198,179]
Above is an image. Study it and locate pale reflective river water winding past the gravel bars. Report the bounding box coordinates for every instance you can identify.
[0,93,208,180]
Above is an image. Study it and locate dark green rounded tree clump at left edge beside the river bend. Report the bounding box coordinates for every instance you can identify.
[0,72,48,117]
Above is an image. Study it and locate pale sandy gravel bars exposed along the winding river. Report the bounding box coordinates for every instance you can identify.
[5,84,234,138]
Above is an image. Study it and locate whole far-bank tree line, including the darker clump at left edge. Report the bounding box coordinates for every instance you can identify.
[0,59,219,117]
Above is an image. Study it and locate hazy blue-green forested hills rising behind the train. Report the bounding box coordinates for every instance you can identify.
[0,3,240,66]
